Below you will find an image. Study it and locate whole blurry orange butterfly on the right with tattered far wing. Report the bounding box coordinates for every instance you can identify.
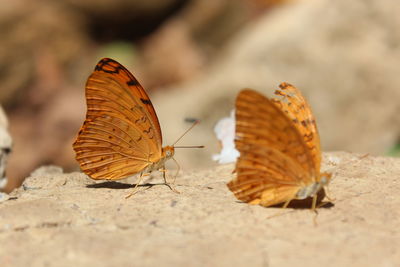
[228,83,331,210]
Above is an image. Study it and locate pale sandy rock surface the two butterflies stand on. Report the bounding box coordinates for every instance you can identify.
[0,152,400,267]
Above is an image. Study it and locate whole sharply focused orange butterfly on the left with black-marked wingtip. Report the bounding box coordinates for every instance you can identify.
[73,58,198,192]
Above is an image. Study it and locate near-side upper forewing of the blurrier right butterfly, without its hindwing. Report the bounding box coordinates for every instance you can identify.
[235,89,315,177]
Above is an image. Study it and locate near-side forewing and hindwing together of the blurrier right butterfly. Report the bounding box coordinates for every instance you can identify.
[228,89,316,206]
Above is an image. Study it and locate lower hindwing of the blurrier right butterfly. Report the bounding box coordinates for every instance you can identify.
[228,144,305,206]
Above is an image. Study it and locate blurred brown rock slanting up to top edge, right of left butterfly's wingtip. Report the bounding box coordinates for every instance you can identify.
[140,0,256,88]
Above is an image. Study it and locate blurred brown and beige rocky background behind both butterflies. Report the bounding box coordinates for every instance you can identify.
[0,0,400,192]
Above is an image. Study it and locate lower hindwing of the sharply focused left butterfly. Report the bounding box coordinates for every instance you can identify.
[74,117,149,180]
